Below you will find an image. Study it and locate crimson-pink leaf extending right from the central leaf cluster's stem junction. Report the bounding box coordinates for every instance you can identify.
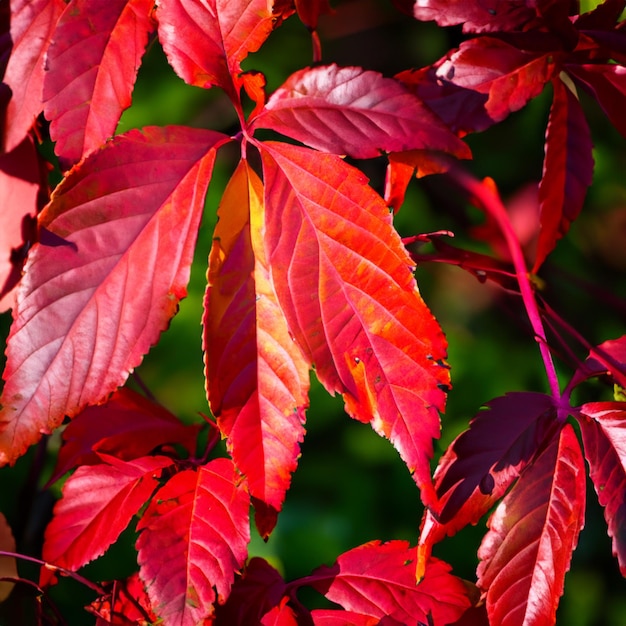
[253,65,470,159]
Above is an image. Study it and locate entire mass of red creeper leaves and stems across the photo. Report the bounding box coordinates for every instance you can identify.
[0,0,626,626]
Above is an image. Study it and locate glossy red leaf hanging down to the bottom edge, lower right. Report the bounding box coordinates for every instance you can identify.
[477,424,585,626]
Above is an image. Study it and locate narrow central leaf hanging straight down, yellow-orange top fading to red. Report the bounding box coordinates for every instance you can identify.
[203,161,309,510]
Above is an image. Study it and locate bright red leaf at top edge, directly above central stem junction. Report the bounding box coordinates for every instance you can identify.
[156,0,278,99]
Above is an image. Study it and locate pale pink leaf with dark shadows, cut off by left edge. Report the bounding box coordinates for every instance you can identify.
[0,138,40,312]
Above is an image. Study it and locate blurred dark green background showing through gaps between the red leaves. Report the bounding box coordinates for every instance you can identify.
[0,0,626,626]
